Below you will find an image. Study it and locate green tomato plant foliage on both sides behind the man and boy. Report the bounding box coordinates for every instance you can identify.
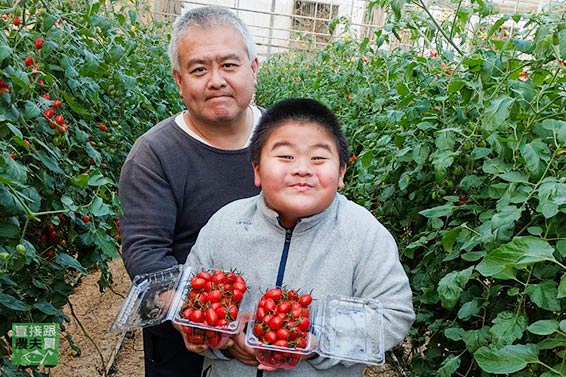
[0,0,566,377]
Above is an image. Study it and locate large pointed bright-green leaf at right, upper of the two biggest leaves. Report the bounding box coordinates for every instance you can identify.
[477,236,556,276]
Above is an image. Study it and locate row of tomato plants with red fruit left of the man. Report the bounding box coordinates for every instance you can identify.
[0,0,181,376]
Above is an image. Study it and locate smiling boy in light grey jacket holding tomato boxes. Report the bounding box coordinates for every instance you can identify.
[187,99,414,377]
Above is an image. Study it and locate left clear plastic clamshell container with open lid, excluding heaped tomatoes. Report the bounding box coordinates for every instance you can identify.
[111,265,249,348]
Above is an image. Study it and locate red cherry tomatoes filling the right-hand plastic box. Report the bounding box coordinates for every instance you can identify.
[252,288,312,369]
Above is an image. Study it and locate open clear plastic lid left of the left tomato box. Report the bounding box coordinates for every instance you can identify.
[111,265,183,331]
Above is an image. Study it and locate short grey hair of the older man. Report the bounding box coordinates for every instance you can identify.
[167,6,257,71]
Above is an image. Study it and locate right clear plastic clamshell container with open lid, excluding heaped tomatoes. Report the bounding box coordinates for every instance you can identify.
[246,295,385,369]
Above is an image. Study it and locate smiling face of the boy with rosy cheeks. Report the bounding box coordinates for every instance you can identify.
[253,121,346,228]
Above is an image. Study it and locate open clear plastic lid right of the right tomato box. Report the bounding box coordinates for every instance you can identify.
[313,295,385,365]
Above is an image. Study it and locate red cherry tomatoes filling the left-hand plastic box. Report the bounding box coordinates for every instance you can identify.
[180,270,247,348]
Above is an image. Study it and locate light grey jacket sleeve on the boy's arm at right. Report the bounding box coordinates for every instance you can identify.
[353,213,415,351]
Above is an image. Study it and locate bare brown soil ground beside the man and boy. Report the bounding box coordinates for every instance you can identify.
[49,259,400,377]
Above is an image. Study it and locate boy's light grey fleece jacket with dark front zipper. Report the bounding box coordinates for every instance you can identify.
[187,194,414,377]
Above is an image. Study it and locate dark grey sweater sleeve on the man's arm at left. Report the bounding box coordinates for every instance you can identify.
[119,150,177,278]
